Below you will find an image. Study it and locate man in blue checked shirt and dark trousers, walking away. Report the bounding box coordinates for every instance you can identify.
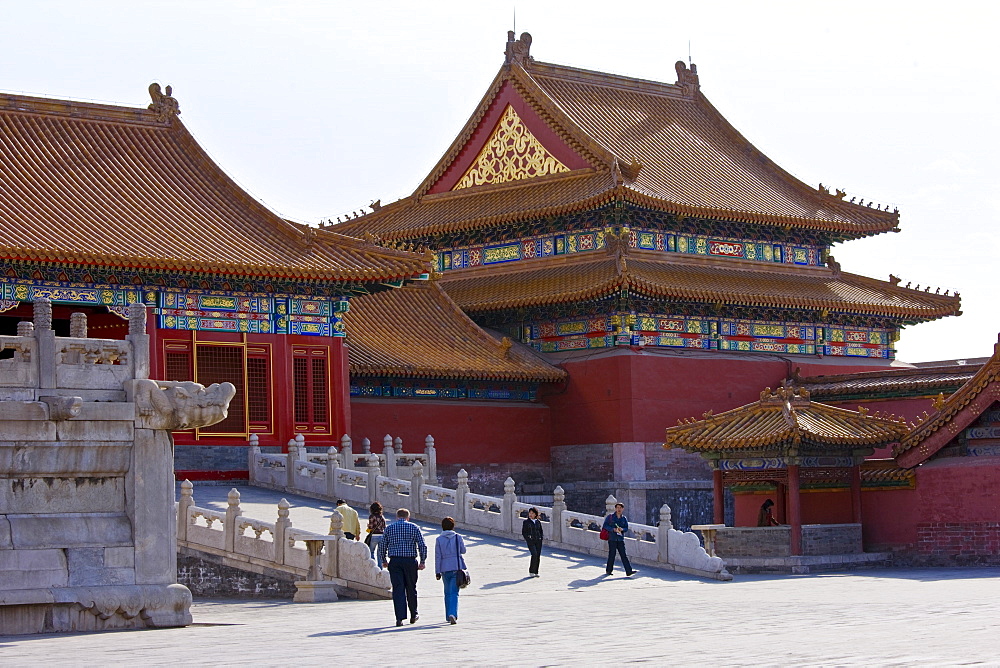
[378,508,427,626]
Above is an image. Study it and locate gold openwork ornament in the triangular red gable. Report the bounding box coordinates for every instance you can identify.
[454,105,569,190]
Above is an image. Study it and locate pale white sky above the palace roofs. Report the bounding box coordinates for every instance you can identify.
[0,0,1000,362]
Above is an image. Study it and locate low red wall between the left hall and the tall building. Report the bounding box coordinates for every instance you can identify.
[351,399,552,466]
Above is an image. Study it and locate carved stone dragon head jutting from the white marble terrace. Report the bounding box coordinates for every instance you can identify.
[133,380,236,431]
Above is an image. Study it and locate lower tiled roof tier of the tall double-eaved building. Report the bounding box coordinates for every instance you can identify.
[442,250,960,321]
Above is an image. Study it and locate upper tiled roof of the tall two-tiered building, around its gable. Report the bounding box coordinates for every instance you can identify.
[334,33,899,239]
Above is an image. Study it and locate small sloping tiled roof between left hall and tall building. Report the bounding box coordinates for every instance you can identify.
[344,281,566,382]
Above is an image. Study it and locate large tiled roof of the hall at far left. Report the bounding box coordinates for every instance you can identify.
[0,87,430,282]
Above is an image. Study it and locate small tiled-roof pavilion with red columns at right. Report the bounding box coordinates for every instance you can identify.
[664,386,909,556]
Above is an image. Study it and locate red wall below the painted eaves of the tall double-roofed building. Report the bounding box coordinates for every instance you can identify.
[541,349,873,445]
